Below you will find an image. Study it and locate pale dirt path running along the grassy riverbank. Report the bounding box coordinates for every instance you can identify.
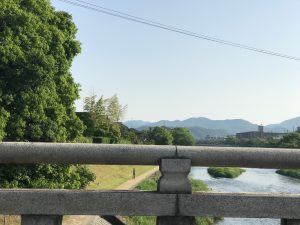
[63,167,159,225]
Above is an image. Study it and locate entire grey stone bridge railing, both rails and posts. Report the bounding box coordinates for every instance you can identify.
[0,143,300,225]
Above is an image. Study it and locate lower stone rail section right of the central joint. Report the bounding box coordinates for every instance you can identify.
[179,192,300,219]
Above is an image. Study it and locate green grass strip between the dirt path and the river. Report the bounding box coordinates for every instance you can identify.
[127,172,221,225]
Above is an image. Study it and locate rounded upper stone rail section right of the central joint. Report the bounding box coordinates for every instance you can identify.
[177,146,300,169]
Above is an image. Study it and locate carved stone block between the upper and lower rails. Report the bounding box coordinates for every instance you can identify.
[158,159,192,194]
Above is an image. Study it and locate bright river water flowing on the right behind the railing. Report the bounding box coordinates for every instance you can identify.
[190,167,300,225]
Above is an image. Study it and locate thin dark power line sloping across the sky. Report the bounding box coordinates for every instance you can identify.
[58,0,300,61]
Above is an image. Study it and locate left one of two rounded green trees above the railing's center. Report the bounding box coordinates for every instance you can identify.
[149,127,173,145]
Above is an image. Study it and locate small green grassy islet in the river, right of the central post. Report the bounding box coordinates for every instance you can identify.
[207,167,246,178]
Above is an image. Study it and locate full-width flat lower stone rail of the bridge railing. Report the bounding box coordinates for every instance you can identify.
[0,189,300,219]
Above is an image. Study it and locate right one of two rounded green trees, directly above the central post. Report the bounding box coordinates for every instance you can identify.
[172,127,195,146]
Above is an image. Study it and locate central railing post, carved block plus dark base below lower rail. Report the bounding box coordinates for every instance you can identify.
[156,158,196,225]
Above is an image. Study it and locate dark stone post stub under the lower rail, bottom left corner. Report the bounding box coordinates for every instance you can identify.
[21,215,62,225]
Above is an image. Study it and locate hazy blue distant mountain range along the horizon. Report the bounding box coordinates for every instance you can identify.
[124,117,300,139]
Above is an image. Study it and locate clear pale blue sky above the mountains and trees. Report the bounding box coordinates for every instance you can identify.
[51,0,300,124]
